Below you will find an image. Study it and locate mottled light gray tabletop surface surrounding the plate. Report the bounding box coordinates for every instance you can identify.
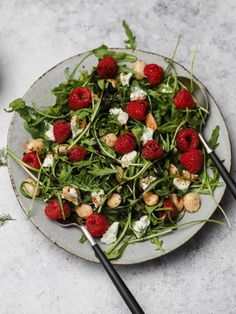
[0,0,236,314]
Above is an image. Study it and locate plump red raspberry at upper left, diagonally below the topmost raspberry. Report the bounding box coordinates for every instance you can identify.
[68,87,92,111]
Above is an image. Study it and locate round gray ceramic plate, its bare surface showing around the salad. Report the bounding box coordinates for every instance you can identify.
[8,49,231,264]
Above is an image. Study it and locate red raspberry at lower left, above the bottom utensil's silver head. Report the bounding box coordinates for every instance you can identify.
[44,198,71,219]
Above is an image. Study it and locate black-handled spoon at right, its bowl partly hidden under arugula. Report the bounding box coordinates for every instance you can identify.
[178,76,236,199]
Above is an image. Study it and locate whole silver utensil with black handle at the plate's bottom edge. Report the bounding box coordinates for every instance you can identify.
[57,213,144,314]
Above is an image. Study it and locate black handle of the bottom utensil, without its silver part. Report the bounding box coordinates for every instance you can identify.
[92,244,144,314]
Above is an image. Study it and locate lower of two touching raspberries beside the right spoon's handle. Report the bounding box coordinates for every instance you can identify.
[180,149,204,174]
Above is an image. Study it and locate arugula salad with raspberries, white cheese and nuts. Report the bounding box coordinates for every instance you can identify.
[8,24,225,259]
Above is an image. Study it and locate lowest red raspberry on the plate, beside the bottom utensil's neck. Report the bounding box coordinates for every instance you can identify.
[85,214,109,238]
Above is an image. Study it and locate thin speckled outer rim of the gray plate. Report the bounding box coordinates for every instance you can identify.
[7,48,232,265]
